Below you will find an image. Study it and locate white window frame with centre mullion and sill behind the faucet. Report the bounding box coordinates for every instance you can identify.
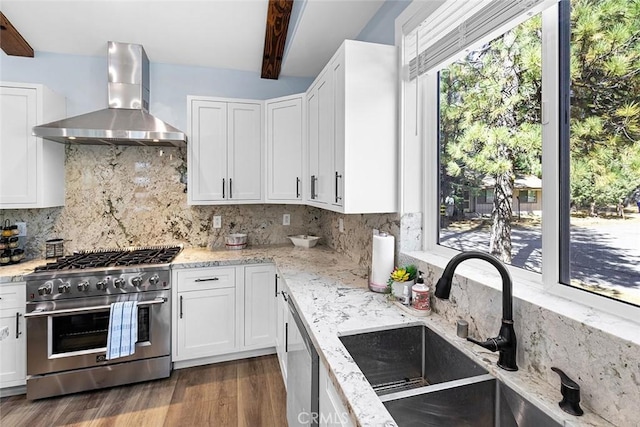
[396,2,640,323]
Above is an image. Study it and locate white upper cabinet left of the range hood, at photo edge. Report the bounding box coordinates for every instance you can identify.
[0,82,66,209]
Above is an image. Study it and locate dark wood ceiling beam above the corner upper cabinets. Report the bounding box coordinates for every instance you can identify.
[262,0,294,80]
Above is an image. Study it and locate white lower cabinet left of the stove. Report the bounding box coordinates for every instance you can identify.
[0,282,27,388]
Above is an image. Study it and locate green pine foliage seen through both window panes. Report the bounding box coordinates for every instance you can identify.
[440,0,640,227]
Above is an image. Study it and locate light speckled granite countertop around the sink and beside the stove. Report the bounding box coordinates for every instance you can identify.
[0,245,609,426]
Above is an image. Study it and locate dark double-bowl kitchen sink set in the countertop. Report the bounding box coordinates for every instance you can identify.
[340,325,562,427]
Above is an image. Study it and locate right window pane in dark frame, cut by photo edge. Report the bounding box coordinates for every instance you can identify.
[561,0,640,306]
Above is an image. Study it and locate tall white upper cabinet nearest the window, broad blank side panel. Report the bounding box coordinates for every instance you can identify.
[306,40,398,213]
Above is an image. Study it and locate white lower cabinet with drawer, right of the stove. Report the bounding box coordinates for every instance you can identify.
[172,264,276,367]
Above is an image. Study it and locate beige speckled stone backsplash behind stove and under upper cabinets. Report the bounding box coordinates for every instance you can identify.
[0,146,322,258]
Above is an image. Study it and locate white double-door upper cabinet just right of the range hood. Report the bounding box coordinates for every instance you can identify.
[187,96,263,205]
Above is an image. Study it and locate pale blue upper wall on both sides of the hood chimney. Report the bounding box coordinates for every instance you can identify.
[0,50,313,130]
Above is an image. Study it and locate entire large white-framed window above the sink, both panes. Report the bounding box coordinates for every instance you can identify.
[404,0,640,318]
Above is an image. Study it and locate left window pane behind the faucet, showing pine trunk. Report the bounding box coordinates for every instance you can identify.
[438,7,542,272]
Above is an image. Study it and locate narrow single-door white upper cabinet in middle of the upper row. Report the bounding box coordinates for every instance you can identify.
[266,94,305,203]
